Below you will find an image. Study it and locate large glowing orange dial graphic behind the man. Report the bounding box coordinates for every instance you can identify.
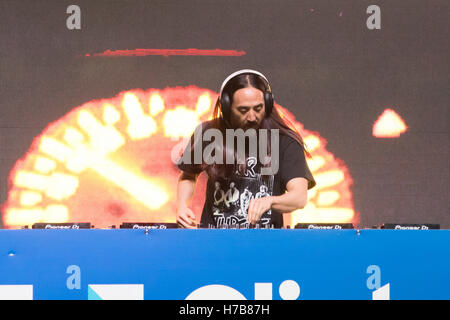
[2,86,359,228]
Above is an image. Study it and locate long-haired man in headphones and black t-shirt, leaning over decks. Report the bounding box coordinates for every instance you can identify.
[177,69,316,228]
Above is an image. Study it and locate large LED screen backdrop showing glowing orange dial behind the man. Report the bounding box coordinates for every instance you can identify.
[0,0,450,228]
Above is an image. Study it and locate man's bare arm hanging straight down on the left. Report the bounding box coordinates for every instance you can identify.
[177,171,198,229]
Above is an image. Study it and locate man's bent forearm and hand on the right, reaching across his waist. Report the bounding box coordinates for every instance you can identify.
[248,178,308,224]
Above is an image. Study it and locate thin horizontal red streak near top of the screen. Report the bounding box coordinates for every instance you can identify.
[85,48,246,57]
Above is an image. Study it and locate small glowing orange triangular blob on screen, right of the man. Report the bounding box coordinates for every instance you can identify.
[372,109,408,138]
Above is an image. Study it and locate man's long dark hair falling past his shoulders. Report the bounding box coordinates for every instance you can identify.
[199,73,311,179]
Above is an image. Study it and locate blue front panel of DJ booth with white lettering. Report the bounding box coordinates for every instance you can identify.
[0,228,450,300]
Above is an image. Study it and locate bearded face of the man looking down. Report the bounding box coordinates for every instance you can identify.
[230,87,265,130]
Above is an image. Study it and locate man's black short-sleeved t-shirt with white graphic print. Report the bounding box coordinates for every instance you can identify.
[177,123,316,228]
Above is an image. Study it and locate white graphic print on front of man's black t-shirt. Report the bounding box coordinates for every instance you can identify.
[211,157,274,228]
